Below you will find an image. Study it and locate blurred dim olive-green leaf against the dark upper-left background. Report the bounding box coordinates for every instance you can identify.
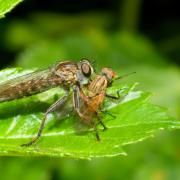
[5,12,110,50]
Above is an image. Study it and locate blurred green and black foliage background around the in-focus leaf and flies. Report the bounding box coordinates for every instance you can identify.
[0,0,180,180]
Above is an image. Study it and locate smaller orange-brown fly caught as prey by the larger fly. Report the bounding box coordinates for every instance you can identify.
[73,68,134,141]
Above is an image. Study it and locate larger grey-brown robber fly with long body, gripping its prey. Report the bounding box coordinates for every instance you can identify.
[0,59,93,146]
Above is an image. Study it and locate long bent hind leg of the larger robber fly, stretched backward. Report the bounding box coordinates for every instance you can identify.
[21,90,69,146]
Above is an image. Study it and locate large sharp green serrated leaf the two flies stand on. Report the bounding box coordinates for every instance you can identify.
[0,69,180,158]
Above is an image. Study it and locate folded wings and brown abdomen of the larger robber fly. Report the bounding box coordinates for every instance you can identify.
[0,69,51,102]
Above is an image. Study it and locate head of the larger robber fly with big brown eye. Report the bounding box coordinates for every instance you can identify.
[77,59,94,84]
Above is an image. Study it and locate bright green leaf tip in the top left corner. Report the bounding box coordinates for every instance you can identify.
[0,0,22,18]
